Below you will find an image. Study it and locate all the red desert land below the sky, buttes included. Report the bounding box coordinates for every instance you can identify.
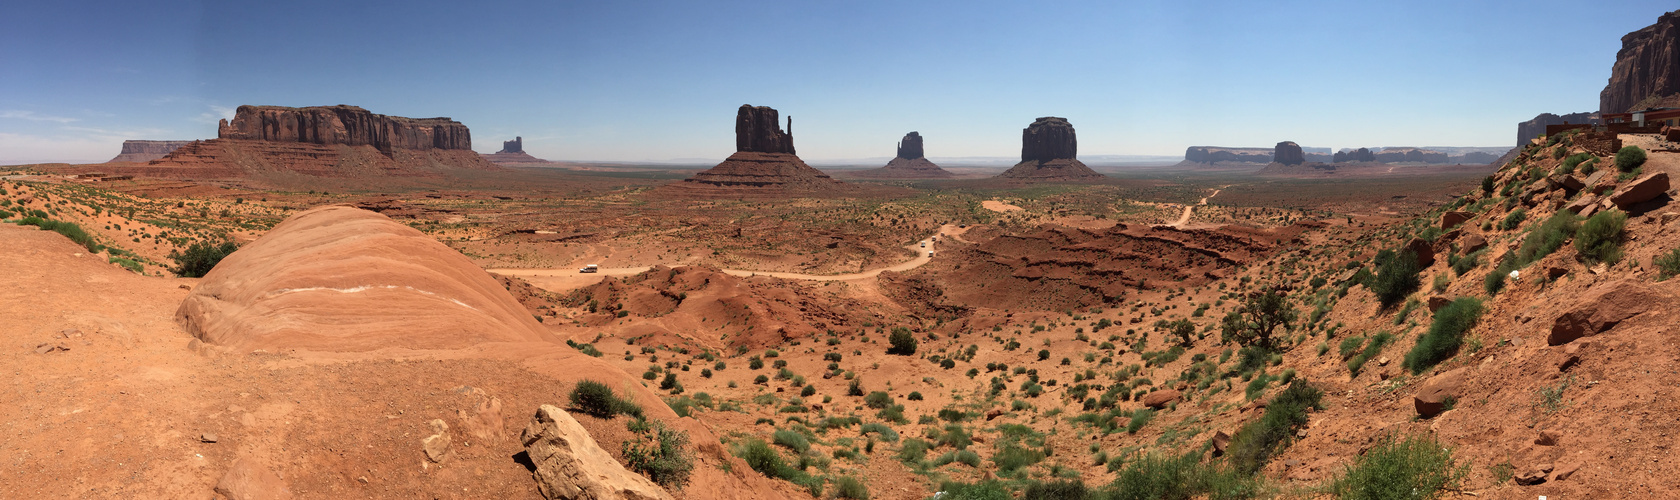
[0,3,1680,500]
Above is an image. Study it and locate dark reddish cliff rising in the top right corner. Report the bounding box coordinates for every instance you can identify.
[1598,10,1680,114]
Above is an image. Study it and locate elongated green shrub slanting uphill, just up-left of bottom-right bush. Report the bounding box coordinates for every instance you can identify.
[1226,378,1324,475]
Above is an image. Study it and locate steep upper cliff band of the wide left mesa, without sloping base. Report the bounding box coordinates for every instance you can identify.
[217,104,472,153]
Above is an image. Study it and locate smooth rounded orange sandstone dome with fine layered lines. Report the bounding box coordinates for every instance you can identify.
[175,206,549,352]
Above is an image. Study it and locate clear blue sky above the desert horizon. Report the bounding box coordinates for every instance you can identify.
[0,0,1680,163]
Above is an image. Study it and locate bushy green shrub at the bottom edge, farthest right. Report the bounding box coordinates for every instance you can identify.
[1331,436,1468,500]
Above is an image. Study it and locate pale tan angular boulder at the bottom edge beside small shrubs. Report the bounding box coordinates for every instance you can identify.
[519,404,672,500]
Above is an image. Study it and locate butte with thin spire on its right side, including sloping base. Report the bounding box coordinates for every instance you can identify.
[670,104,847,195]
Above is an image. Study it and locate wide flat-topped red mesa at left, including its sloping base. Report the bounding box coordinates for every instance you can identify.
[146,104,502,181]
